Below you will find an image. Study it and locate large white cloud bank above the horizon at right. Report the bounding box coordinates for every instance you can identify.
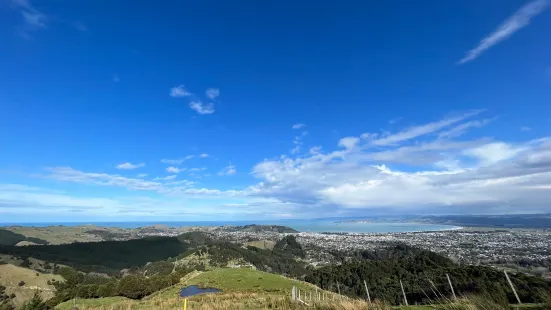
[247,113,551,213]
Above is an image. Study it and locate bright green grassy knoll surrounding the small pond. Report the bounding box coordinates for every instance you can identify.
[56,268,365,310]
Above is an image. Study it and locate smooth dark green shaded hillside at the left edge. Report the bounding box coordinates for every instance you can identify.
[0,237,189,274]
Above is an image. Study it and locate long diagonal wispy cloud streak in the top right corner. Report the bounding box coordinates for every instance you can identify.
[458,0,549,64]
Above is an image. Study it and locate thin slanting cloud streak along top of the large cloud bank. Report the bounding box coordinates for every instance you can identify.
[371,110,481,146]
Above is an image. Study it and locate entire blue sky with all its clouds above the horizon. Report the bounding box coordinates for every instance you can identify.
[0,0,551,222]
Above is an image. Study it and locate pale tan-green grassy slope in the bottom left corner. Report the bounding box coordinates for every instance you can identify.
[0,264,63,305]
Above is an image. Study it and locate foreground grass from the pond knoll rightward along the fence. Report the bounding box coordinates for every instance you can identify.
[51,268,545,310]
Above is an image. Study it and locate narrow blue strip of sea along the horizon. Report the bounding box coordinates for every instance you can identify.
[0,220,460,233]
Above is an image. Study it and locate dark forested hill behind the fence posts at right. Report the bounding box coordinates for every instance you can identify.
[306,245,551,304]
